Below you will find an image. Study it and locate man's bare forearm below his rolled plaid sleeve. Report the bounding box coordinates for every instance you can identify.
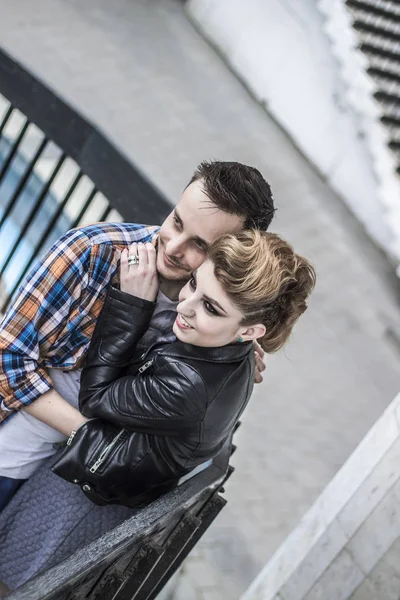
[22,389,88,436]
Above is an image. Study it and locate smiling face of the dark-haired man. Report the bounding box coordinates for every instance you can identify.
[157,181,243,282]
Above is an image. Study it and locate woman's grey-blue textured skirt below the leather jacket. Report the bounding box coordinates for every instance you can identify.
[0,457,135,590]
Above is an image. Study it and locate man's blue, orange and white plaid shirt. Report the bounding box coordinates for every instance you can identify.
[0,223,159,422]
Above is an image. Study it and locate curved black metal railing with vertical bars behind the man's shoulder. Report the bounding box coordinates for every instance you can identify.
[0,50,170,313]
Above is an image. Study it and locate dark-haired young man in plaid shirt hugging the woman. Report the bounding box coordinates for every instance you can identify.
[0,162,274,508]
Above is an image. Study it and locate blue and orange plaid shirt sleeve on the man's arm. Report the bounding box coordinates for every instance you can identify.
[0,230,92,421]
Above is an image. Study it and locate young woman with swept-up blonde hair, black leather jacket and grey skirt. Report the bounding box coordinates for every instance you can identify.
[0,231,315,589]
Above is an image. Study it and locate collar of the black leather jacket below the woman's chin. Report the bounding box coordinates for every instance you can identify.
[160,340,253,363]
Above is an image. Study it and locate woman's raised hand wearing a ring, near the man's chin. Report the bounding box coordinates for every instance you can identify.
[120,242,158,302]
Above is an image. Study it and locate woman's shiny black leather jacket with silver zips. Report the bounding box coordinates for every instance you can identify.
[53,288,254,506]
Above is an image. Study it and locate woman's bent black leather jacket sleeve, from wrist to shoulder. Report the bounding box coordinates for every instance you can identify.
[79,289,206,435]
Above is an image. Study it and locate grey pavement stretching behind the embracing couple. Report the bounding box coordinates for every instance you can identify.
[0,0,400,600]
